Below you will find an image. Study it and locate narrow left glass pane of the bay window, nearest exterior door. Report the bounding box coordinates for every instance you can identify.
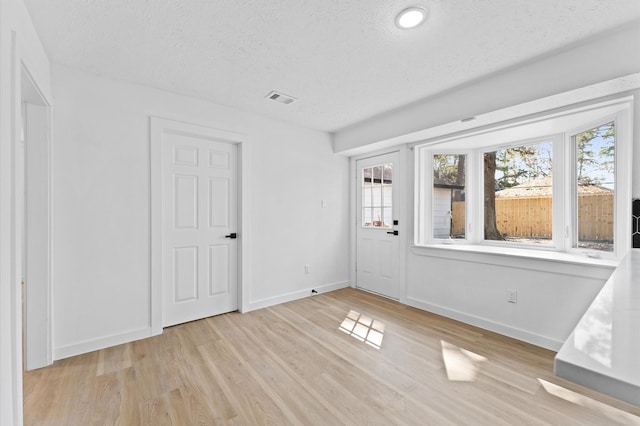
[432,154,466,238]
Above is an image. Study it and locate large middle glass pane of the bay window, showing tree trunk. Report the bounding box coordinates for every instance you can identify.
[484,142,553,244]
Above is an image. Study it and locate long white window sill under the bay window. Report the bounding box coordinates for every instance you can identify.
[411,243,619,279]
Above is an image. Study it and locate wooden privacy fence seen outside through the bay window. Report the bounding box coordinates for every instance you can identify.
[451,193,613,241]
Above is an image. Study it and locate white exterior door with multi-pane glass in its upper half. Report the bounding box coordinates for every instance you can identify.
[356,152,400,299]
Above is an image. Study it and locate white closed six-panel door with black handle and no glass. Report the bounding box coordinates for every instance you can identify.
[162,132,238,327]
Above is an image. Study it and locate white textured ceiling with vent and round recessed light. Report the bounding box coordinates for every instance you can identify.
[25,0,640,131]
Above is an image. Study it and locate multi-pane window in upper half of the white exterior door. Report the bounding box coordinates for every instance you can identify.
[362,163,393,228]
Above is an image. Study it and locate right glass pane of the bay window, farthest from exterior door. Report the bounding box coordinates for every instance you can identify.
[574,123,616,251]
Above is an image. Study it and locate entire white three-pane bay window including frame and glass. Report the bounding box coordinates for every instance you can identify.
[415,97,632,259]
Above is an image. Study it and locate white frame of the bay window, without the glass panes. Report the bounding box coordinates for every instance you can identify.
[414,96,634,263]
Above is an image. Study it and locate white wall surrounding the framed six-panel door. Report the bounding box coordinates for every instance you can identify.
[52,66,349,358]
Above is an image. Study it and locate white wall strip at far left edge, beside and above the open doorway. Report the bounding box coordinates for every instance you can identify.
[0,0,50,425]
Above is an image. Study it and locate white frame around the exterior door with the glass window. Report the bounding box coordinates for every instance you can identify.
[349,145,413,303]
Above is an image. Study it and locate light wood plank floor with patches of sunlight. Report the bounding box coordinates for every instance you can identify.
[24,289,640,425]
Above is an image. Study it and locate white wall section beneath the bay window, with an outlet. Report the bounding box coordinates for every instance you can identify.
[405,248,613,350]
